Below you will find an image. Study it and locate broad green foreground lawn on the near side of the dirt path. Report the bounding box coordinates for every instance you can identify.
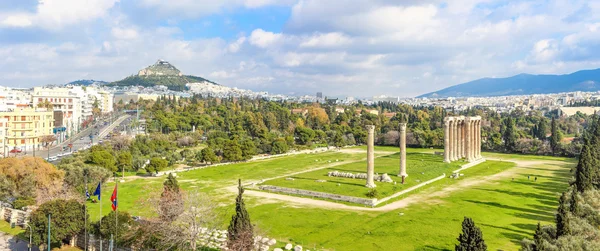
[249,161,570,250]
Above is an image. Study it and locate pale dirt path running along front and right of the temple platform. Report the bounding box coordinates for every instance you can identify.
[237,158,567,212]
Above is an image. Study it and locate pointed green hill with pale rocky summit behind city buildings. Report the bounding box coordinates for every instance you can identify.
[108,59,217,91]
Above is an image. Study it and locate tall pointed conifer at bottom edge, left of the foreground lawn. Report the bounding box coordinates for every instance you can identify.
[227,180,254,251]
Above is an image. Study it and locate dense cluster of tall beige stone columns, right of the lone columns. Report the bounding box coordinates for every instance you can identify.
[444,116,482,163]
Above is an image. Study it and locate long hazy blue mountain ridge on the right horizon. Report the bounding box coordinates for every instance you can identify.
[419,69,600,98]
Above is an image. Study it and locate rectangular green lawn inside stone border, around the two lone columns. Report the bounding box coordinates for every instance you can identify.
[263,153,465,199]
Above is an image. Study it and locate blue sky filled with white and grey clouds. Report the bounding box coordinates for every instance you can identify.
[0,0,600,97]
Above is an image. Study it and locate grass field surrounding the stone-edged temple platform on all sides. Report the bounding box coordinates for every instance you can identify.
[77,147,574,250]
